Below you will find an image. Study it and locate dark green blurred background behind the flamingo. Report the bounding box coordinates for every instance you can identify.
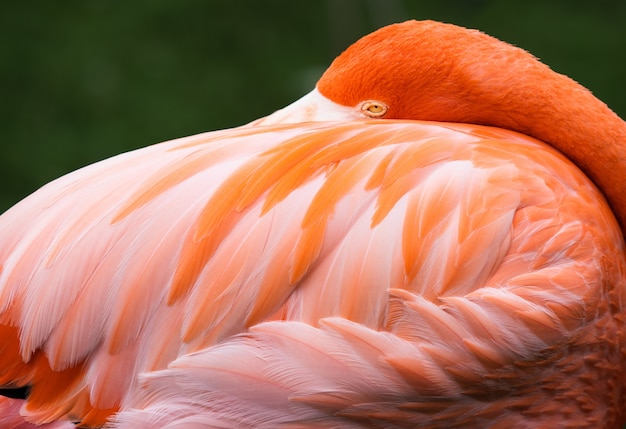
[0,0,626,211]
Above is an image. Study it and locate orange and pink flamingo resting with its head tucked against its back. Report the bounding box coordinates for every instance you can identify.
[0,21,626,428]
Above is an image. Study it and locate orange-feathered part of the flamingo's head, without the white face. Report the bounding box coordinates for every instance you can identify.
[317,21,554,127]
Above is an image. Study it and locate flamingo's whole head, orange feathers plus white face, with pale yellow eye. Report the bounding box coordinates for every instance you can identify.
[261,21,528,128]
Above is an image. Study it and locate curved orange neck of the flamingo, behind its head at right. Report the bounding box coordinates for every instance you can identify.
[482,63,626,237]
